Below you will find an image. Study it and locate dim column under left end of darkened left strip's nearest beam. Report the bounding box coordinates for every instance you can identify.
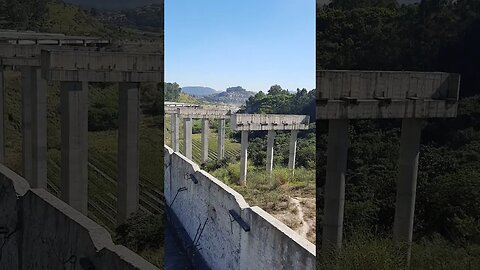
[60,82,88,214]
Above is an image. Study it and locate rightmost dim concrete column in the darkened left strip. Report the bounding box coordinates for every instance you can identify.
[117,83,140,225]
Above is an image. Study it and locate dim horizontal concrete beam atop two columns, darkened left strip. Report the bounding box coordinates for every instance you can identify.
[41,50,163,82]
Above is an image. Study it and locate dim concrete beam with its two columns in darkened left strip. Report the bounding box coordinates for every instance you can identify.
[41,50,163,224]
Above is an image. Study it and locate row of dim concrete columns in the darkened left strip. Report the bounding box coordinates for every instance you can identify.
[0,67,139,223]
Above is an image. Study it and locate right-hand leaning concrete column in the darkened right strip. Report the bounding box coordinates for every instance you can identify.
[393,119,422,264]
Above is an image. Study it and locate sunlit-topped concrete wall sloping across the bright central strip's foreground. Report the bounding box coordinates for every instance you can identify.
[164,146,315,270]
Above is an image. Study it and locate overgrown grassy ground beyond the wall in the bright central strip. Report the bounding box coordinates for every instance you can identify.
[165,117,316,243]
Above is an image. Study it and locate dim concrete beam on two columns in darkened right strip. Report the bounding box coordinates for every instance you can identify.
[317,70,460,266]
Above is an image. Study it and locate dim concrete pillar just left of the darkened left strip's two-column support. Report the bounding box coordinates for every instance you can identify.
[21,67,47,189]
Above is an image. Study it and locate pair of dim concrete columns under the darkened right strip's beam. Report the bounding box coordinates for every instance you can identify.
[322,118,421,262]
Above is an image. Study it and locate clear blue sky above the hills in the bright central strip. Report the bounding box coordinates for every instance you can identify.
[165,0,315,91]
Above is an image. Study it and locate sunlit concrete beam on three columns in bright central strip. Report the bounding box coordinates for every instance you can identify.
[230,114,310,185]
